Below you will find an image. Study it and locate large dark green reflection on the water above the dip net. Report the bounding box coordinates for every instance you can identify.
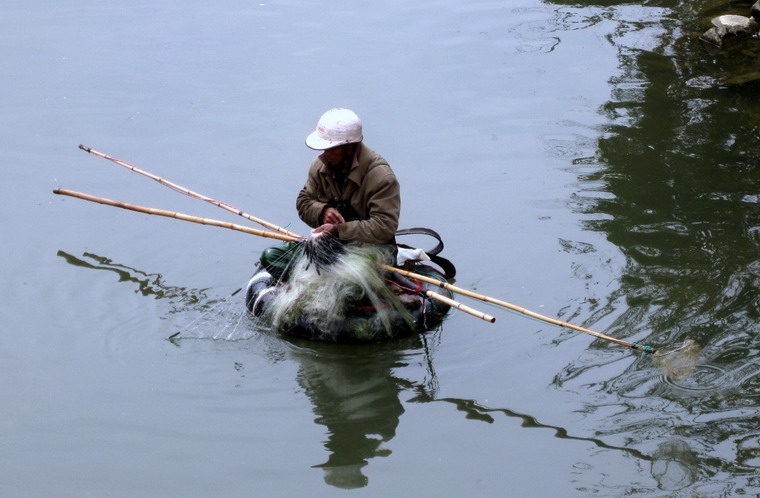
[576,10,760,347]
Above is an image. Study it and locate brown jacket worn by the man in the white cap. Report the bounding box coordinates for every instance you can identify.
[296,143,401,244]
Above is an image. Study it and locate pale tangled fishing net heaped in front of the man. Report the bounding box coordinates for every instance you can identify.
[263,237,412,340]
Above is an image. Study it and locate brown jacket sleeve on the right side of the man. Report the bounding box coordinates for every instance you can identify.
[336,165,401,244]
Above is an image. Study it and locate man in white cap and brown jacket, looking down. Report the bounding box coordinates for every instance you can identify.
[296,109,401,246]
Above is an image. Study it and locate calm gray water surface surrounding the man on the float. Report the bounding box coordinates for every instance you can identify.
[0,0,760,496]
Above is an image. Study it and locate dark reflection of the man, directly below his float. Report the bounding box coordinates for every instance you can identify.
[284,334,435,489]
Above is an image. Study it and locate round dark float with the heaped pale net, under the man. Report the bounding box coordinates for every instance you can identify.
[246,239,449,342]
